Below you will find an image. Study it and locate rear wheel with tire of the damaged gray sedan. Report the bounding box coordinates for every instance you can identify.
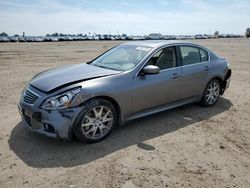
[201,79,221,107]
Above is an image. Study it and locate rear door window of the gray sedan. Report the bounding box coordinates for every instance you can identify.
[180,46,208,65]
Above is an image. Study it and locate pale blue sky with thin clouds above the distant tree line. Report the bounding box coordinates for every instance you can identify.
[0,0,250,35]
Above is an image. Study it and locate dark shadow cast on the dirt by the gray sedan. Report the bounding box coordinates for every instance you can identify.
[8,97,232,168]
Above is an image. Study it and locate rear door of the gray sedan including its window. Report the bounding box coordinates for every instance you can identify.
[179,45,211,99]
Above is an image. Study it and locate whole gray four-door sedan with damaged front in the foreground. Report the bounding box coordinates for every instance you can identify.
[19,41,231,142]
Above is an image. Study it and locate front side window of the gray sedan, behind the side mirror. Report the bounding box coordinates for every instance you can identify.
[147,47,176,70]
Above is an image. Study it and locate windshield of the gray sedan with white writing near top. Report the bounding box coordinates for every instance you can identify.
[91,45,151,71]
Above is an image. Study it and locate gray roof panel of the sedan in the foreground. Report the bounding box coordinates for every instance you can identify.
[123,40,199,48]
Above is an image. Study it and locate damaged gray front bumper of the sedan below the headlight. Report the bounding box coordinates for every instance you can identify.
[18,102,80,140]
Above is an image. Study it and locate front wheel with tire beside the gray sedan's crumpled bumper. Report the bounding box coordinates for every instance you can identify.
[74,98,117,143]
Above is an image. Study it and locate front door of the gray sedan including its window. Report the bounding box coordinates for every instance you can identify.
[133,47,182,113]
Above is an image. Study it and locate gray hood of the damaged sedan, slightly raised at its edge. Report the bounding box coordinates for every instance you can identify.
[30,64,121,92]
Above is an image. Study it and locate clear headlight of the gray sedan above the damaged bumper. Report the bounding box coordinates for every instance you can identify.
[41,88,81,110]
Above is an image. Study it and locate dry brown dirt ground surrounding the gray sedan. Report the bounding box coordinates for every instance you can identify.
[0,39,250,188]
